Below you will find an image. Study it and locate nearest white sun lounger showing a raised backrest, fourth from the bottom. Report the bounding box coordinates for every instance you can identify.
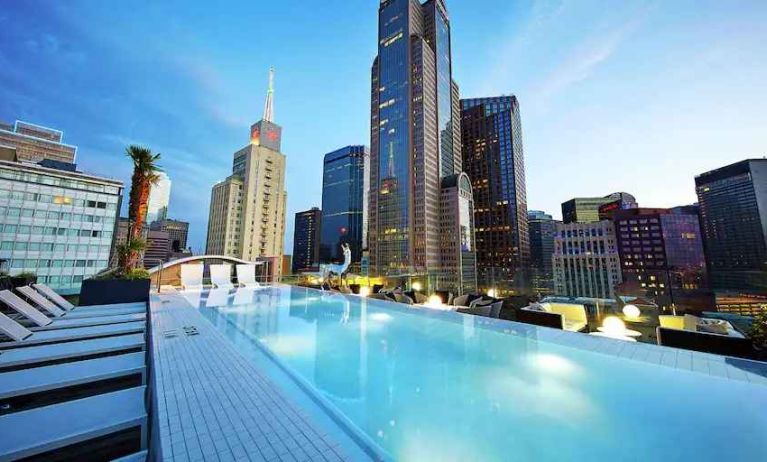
[0,315,146,350]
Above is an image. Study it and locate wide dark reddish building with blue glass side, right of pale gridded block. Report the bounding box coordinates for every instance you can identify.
[613,206,715,311]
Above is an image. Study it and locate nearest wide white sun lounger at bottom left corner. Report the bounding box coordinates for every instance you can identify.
[0,387,147,460]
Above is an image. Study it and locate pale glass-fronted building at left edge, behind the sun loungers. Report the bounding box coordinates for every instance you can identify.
[0,153,123,293]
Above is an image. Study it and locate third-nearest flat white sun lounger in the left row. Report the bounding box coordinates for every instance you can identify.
[0,332,146,370]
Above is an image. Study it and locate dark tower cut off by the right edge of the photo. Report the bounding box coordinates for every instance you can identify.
[695,159,767,294]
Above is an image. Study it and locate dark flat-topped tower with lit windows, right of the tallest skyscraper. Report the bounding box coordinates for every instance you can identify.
[461,96,530,292]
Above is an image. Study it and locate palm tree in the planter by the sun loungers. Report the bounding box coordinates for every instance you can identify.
[120,145,162,273]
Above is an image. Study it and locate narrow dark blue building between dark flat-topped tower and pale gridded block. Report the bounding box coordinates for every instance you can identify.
[527,210,561,294]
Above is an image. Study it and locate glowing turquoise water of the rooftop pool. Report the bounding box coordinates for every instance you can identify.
[191,287,767,461]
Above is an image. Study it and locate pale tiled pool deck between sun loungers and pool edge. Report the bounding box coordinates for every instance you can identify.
[151,294,369,461]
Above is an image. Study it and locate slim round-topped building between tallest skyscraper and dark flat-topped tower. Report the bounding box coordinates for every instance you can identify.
[437,173,477,293]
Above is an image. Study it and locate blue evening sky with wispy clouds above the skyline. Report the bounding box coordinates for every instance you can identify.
[0,0,767,252]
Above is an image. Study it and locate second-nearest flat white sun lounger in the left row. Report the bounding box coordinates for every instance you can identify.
[0,352,146,400]
